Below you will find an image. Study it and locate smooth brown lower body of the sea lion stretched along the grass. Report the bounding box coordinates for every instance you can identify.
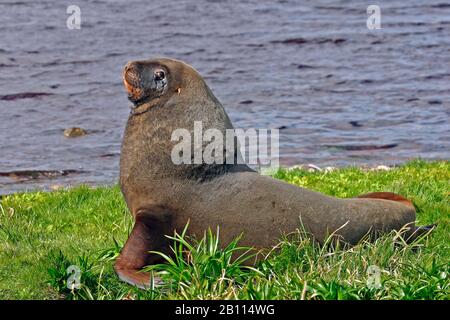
[126,172,415,248]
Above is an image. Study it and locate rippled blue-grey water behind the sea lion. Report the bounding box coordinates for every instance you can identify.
[0,0,450,194]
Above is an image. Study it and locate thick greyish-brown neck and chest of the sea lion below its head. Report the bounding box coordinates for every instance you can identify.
[120,89,252,188]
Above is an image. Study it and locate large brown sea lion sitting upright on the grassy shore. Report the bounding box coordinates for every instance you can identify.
[115,58,428,287]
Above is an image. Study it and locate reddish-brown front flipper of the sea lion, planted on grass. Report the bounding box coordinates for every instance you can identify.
[114,207,173,289]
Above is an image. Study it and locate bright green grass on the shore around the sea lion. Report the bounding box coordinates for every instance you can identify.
[0,161,450,299]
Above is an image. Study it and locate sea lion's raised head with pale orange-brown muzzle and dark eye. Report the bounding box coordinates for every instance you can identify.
[122,58,204,108]
